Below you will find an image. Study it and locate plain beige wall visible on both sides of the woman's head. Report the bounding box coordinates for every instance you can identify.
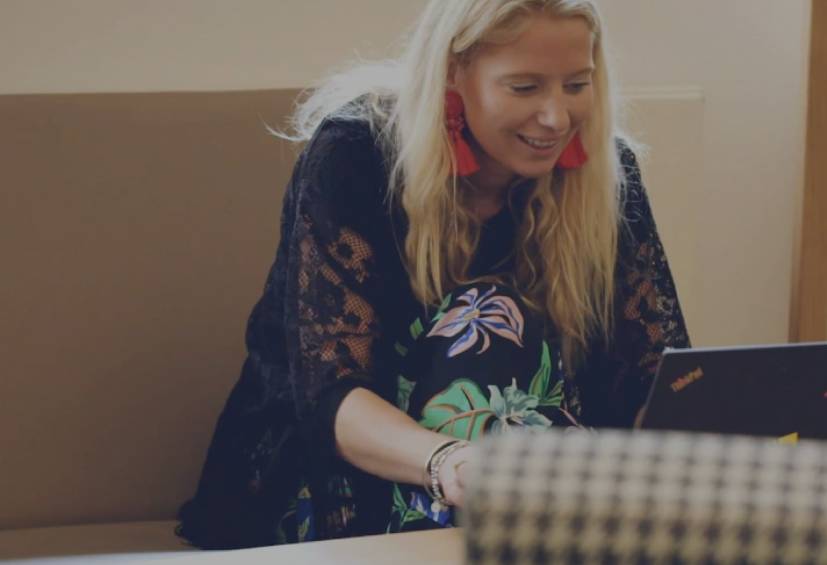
[0,0,809,345]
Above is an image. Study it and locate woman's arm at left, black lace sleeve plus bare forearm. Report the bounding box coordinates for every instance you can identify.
[285,118,467,503]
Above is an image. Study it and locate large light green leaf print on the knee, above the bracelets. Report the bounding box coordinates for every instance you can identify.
[419,379,494,440]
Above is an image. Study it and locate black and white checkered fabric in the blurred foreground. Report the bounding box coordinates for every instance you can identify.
[460,431,827,565]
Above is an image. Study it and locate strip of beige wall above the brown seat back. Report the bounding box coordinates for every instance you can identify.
[0,0,425,93]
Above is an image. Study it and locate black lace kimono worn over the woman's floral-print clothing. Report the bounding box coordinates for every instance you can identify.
[178,115,689,548]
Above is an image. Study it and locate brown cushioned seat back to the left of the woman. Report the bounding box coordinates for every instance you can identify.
[0,90,304,529]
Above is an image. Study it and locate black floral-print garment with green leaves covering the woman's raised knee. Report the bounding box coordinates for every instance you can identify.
[387,283,579,532]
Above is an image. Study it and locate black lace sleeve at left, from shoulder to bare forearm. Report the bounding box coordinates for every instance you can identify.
[284,121,387,440]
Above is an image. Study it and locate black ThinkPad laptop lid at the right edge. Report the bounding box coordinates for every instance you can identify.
[640,342,827,443]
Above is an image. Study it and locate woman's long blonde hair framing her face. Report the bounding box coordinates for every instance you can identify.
[282,0,623,369]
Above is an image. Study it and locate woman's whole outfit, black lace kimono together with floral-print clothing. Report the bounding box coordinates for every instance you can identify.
[178,118,689,548]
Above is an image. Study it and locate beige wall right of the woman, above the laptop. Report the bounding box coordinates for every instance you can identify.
[599,0,810,345]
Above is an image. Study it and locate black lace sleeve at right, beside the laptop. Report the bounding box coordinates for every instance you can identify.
[583,147,690,427]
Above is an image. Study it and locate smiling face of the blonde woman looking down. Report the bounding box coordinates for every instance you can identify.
[449,14,594,186]
